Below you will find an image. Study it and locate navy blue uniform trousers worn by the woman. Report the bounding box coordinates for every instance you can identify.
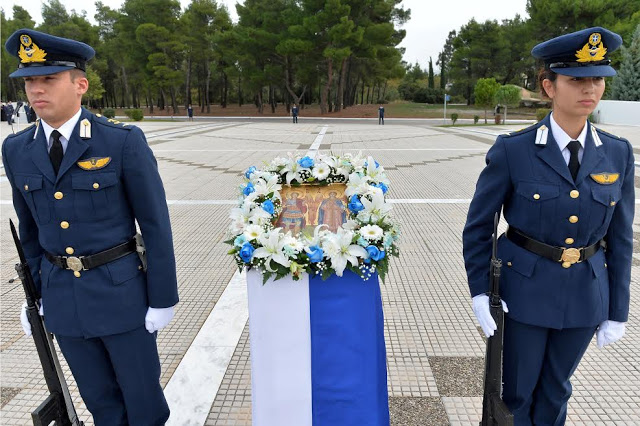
[502,315,596,426]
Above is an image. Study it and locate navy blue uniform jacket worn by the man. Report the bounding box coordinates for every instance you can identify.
[2,109,178,337]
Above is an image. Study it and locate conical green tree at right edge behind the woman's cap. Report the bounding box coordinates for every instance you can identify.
[611,25,640,101]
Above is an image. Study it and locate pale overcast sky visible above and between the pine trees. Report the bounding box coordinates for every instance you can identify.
[2,0,528,69]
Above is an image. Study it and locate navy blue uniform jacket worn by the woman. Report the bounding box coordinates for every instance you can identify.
[463,116,635,329]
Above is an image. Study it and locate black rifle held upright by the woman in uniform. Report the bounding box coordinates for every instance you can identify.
[480,212,513,426]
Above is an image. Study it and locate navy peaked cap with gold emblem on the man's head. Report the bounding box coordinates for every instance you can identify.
[4,28,96,78]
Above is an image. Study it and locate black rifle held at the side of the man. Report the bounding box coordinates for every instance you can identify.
[9,219,84,426]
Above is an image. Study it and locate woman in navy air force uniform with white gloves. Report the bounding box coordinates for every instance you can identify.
[463,27,635,425]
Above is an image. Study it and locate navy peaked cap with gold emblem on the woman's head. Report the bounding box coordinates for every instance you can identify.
[531,27,622,77]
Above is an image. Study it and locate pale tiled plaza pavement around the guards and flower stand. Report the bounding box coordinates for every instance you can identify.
[0,119,640,425]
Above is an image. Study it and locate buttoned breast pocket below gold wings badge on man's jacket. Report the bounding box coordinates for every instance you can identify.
[71,172,118,220]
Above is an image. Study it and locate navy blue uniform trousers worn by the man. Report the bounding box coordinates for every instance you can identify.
[56,327,169,426]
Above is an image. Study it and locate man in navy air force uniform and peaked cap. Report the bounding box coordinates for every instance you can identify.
[2,29,178,426]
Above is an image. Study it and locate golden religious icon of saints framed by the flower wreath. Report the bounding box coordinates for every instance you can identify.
[276,183,348,235]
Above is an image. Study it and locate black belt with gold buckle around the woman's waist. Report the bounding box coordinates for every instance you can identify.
[506,226,604,268]
